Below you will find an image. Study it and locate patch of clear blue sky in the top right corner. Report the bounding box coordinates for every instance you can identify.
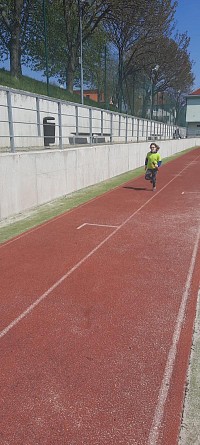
[175,0,200,90]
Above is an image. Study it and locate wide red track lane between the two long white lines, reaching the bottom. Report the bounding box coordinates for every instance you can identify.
[2,147,199,445]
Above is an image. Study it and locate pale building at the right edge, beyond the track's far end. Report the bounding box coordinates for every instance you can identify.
[186,88,200,137]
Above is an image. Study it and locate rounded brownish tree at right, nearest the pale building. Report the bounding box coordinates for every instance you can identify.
[124,10,194,117]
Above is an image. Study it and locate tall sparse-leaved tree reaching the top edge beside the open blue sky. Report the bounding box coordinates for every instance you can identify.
[104,0,176,110]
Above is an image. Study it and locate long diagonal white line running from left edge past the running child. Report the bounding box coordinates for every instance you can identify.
[0,156,200,338]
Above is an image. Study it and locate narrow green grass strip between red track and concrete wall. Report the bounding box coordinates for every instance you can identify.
[0,147,198,243]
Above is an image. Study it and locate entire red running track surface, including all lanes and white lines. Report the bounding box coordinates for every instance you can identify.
[0,149,200,445]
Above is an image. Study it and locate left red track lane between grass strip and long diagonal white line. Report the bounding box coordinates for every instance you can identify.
[0,150,198,329]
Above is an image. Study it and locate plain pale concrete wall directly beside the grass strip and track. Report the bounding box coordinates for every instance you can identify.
[0,138,200,220]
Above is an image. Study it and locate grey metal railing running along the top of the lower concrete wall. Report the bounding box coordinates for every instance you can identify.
[0,86,185,152]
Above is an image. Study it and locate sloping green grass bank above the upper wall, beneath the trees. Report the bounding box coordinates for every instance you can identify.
[0,69,114,110]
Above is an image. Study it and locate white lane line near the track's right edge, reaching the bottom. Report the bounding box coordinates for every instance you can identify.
[147,226,200,445]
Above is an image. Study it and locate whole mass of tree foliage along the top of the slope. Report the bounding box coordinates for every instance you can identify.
[0,0,194,120]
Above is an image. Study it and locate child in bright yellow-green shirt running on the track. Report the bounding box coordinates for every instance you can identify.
[145,142,162,192]
